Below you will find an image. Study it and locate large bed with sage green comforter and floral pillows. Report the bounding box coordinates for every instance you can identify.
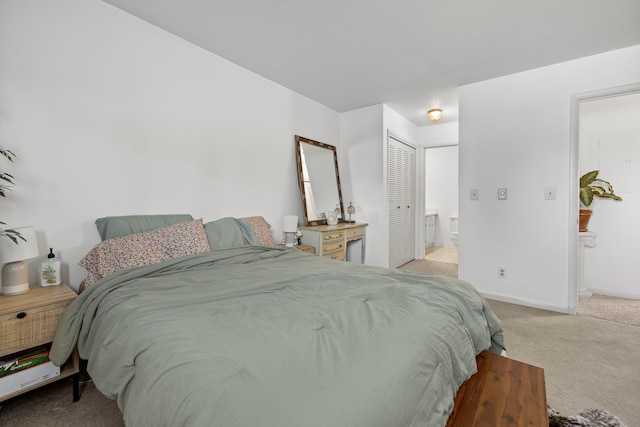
[50,217,504,427]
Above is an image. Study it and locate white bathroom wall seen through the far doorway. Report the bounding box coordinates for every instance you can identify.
[425,145,458,247]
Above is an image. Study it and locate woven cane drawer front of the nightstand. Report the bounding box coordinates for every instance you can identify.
[0,301,71,354]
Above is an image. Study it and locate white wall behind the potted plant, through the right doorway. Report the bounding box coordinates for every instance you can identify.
[579,93,640,298]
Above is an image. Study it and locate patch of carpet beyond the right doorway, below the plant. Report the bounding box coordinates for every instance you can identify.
[578,294,640,328]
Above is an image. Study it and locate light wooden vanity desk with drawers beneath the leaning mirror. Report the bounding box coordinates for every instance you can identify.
[300,223,368,264]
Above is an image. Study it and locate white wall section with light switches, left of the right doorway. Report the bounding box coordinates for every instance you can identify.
[459,46,640,312]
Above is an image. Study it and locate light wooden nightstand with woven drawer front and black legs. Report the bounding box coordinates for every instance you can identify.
[0,284,80,402]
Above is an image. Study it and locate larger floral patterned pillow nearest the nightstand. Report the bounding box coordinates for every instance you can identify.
[79,219,211,280]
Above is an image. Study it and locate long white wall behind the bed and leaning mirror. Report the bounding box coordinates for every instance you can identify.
[0,0,342,288]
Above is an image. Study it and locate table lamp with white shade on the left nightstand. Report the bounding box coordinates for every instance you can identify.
[0,227,40,296]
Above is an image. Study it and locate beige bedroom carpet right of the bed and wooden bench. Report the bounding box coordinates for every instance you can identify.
[489,301,640,427]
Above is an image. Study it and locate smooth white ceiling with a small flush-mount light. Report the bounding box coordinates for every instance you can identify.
[104,0,640,126]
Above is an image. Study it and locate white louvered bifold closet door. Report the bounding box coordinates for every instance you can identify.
[387,136,416,268]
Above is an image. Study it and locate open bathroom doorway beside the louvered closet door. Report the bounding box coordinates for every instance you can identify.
[424,145,459,269]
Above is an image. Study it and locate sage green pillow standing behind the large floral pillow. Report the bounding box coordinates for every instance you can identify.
[96,214,193,240]
